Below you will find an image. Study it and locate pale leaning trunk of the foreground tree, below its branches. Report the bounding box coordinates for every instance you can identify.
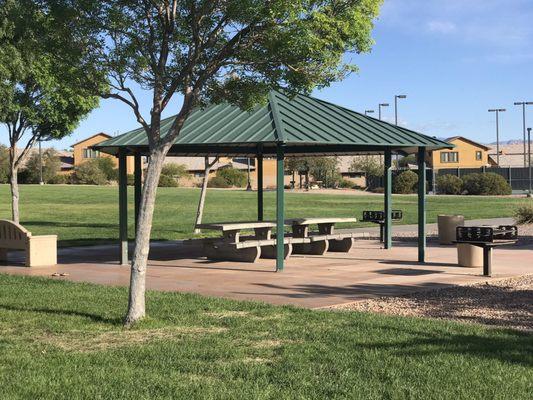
[124,146,168,326]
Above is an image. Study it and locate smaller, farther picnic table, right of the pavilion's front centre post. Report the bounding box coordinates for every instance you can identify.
[285,217,357,255]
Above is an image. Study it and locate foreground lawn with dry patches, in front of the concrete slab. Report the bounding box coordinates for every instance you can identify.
[0,274,533,400]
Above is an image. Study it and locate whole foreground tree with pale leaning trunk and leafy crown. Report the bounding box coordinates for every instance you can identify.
[81,0,381,325]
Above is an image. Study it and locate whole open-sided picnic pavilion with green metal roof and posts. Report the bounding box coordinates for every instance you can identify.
[93,91,454,271]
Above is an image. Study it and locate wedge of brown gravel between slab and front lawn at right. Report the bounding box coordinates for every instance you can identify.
[330,275,533,332]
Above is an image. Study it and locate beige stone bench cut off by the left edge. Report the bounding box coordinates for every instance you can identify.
[0,219,57,267]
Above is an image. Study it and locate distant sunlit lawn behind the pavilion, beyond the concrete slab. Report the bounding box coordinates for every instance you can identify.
[0,185,524,245]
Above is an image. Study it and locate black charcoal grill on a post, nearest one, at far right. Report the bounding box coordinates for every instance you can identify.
[455,225,518,276]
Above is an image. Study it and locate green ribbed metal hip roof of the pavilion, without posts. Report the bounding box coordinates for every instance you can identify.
[94,92,454,155]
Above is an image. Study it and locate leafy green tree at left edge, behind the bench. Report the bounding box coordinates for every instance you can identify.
[0,0,103,223]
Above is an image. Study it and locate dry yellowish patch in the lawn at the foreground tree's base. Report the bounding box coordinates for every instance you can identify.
[36,327,227,352]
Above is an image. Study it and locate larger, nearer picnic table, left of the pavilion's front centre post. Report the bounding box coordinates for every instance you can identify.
[188,221,305,262]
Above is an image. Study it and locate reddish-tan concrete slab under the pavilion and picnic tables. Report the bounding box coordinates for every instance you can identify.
[0,240,533,308]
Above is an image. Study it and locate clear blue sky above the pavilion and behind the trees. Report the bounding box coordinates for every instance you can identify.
[0,0,533,148]
